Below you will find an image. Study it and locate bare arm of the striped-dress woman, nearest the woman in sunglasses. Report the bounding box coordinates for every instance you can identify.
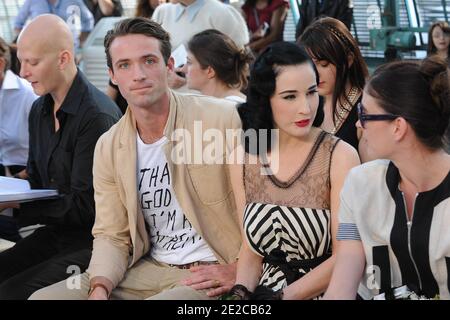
[284,141,360,300]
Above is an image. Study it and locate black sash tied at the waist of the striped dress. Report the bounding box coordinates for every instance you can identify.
[263,249,331,285]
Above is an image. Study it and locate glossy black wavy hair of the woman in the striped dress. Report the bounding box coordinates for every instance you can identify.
[238,42,324,154]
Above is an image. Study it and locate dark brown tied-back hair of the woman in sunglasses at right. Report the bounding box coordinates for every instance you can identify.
[366,55,450,150]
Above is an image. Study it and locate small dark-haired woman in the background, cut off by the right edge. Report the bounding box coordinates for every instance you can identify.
[427,21,450,64]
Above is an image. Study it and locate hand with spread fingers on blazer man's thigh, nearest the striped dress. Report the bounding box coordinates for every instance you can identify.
[181,263,236,297]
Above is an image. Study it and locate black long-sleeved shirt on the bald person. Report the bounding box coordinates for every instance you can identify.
[18,71,121,233]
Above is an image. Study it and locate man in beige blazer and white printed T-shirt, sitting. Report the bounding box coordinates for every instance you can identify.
[31,18,241,299]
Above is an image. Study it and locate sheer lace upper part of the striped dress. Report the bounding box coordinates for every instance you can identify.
[244,131,339,209]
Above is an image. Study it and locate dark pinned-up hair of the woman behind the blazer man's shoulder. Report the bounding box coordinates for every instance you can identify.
[188,29,253,90]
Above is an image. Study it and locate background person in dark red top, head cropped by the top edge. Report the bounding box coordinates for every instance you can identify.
[242,0,289,53]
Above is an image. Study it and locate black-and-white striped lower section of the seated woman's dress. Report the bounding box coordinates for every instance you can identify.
[244,202,331,290]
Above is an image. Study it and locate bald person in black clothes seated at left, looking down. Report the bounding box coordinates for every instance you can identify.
[0,15,121,299]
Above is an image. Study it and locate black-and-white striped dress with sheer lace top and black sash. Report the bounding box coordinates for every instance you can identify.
[243,131,338,290]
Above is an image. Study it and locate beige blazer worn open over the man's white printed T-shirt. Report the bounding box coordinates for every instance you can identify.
[88,92,241,286]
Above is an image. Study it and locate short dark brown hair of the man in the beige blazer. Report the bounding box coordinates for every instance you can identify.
[104,17,172,70]
